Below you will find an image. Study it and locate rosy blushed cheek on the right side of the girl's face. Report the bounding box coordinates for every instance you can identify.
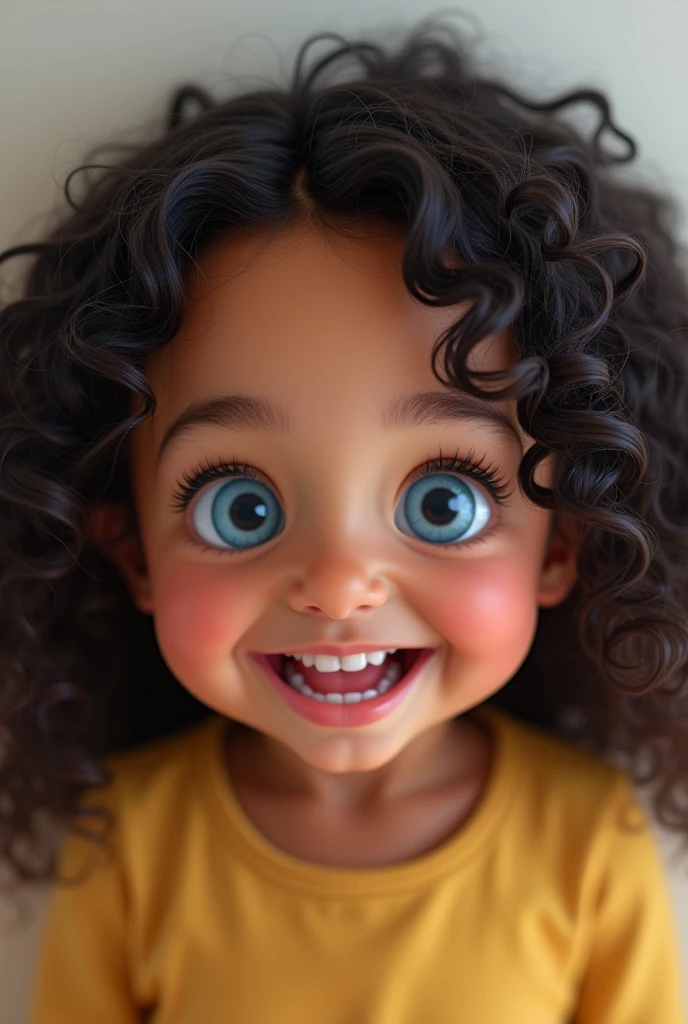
[425,561,538,659]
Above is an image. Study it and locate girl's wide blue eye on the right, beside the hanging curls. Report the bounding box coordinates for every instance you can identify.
[394,473,490,545]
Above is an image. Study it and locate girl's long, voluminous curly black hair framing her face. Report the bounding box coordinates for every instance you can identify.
[0,24,688,905]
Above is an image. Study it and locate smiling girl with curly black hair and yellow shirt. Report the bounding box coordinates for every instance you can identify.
[0,18,688,1024]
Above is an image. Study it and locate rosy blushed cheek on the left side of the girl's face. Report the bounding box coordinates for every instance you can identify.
[150,563,247,682]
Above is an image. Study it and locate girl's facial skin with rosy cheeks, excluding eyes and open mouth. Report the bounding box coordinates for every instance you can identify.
[111,220,574,772]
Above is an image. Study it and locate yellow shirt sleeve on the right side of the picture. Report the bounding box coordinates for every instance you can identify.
[574,776,688,1024]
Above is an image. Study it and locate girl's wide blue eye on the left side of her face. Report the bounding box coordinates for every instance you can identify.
[191,478,284,551]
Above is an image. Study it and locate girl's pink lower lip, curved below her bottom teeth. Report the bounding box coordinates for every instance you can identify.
[250,648,435,728]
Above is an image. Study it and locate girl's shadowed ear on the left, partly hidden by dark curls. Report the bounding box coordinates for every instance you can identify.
[91,503,153,614]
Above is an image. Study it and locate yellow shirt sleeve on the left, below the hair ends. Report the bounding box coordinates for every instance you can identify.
[29,778,143,1024]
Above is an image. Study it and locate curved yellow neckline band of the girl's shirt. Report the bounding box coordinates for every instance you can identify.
[197,705,522,899]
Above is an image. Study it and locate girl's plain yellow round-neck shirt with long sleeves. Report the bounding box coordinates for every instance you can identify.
[30,707,685,1024]
